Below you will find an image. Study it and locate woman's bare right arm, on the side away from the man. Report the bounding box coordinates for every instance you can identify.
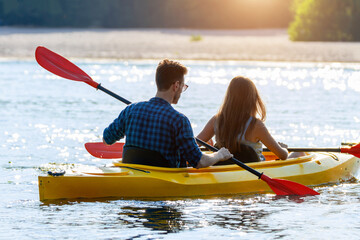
[254,120,288,160]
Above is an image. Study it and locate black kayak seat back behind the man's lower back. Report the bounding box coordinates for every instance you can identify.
[122,146,170,167]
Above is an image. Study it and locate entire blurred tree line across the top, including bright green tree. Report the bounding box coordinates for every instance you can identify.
[0,0,360,41]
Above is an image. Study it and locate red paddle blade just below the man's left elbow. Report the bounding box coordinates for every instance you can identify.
[85,142,124,159]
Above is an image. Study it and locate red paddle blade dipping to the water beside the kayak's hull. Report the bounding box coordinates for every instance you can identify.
[261,174,320,196]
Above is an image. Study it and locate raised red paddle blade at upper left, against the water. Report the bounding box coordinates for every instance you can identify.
[35,47,99,88]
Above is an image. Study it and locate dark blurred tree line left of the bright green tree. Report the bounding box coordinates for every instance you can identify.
[0,0,291,29]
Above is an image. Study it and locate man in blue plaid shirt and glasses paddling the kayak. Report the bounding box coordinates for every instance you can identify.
[103,59,232,168]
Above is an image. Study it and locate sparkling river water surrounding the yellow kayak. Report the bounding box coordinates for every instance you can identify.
[0,60,360,239]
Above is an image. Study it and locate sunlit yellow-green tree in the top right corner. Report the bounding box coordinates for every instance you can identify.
[288,0,360,41]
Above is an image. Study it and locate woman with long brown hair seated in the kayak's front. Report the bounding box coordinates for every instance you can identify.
[197,76,304,161]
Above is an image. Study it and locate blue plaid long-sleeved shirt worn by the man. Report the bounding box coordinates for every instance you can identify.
[103,97,202,167]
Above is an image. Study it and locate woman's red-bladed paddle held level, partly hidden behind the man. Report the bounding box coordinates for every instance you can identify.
[85,142,360,159]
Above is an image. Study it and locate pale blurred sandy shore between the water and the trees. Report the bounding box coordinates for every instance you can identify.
[0,27,360,64]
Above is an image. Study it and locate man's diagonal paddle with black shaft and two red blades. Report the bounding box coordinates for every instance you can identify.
[35,47,319,195]
